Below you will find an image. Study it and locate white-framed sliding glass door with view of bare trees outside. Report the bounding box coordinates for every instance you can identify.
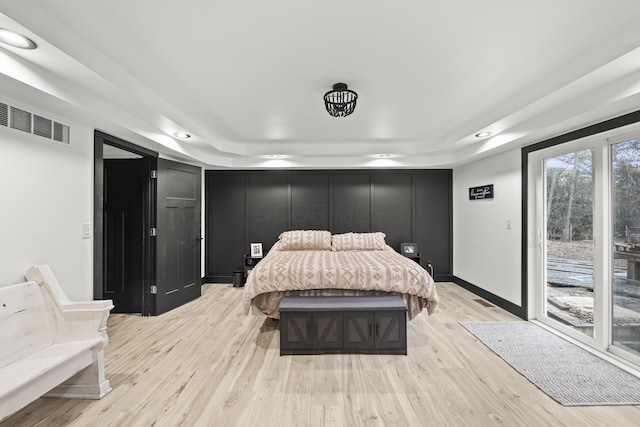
[528,127,640,367]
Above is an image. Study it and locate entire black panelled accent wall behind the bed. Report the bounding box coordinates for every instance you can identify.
[205,169,453,283]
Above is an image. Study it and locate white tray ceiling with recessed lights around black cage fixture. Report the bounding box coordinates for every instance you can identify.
[0,0,640,168]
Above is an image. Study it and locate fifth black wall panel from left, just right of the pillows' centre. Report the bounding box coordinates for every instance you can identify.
[371,173,412,249]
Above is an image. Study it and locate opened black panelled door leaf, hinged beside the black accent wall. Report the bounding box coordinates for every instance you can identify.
[155,159,202,314]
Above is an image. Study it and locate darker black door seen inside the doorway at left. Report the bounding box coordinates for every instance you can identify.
[102,159,145,313]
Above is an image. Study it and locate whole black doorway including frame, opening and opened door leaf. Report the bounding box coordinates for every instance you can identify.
[93,131,202,316]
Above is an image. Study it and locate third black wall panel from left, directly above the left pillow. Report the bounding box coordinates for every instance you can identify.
[291,173,330,230]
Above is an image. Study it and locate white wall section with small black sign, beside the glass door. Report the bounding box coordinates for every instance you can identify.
[453,149,522,306]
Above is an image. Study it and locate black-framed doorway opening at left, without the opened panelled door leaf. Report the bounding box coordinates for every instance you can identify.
[93,135,158,315]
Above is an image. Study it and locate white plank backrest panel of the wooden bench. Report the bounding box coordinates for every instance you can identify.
[0,282,53,368]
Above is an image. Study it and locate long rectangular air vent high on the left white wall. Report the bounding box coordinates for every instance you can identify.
[0,102,69,144]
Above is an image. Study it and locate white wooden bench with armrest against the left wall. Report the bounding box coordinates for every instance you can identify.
[0,265,113,421]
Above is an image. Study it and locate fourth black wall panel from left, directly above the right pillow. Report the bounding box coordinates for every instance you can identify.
[332,174,371,233]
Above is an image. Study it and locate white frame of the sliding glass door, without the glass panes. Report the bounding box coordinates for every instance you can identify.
[522,119,640,372]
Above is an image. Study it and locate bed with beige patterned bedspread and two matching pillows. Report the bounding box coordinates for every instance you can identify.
[243,230,438,320]
